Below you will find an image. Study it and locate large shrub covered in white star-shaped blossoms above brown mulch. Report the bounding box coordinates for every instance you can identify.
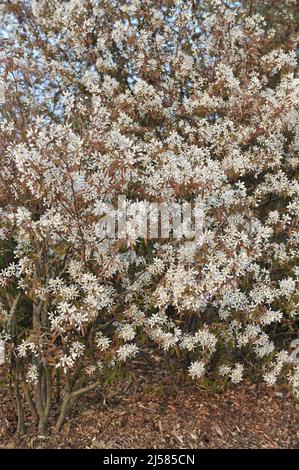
[0,0,299,433]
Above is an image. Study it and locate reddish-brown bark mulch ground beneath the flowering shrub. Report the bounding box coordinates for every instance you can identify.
[0,354,299,449]
